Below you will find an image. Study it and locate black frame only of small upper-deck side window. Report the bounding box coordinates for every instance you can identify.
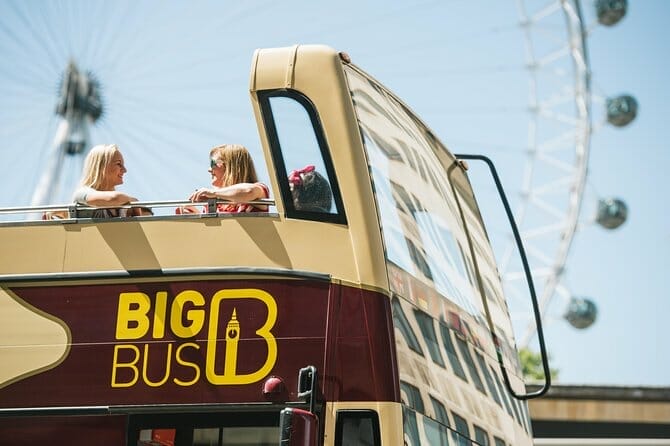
[256,88,347,225]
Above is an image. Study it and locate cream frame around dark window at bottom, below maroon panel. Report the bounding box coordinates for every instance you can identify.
[323,401,403,446]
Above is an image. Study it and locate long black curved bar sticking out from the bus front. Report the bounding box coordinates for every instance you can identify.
[454,154,551,400]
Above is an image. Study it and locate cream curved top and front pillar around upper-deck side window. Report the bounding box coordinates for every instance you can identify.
[252,45,388,289]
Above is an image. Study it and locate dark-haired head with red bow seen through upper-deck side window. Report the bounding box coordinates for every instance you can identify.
[288,166,333,212]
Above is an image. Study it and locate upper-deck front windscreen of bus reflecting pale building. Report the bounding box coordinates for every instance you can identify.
[344,66,482,317]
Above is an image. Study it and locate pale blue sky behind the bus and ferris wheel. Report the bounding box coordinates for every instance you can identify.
[0,0,670,386]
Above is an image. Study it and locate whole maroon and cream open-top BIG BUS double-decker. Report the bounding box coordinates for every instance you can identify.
[0,45,548,446]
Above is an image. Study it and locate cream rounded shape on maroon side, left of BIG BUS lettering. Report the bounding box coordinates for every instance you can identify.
[0,289,70,388]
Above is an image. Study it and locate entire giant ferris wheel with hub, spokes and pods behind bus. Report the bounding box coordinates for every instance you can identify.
[0,0,637,358]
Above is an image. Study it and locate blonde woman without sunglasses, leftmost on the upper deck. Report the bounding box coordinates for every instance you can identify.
[74,144,139,218]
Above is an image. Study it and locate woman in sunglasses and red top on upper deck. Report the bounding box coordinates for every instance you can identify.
[182,144,270,213]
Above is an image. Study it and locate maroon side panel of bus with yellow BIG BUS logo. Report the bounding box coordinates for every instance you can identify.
[0,277,398,408]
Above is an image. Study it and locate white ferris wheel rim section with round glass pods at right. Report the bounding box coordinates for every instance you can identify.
[494,0,637,347]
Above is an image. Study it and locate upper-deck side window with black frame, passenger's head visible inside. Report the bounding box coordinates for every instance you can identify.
[259,90,346,223]
